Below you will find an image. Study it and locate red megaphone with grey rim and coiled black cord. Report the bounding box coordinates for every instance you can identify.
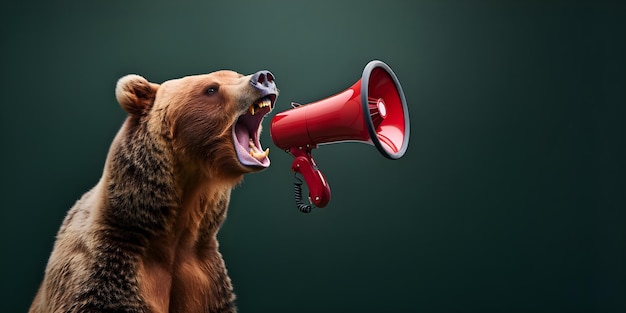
[270,60,410,213]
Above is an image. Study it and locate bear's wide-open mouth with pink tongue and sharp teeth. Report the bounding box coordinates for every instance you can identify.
[233,94,276,168]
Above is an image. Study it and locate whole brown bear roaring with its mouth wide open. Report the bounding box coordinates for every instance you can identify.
[29,70,278,313]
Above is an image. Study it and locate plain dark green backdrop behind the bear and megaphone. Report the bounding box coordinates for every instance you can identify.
[0,0,626,312]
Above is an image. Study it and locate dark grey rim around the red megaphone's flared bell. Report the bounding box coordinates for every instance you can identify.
[361,60,411,160]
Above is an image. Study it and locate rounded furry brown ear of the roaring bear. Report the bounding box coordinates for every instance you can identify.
[115,74,159,115]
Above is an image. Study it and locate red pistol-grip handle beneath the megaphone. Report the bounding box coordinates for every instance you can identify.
[289,147,330,208]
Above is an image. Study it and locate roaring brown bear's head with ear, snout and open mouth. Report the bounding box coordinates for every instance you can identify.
[115,71,278,177]
